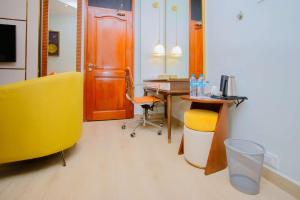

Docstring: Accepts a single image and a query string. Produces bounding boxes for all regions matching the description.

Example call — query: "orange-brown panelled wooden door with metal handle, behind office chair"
[85,6,133,121]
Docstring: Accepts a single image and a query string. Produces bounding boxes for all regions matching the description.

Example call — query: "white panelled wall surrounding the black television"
[0,0,39,84]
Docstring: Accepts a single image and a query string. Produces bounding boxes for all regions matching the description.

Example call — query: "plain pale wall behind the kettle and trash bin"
[206,0,300,182]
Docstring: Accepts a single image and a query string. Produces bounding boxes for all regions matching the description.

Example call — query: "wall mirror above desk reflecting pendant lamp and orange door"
[165,0,204,77]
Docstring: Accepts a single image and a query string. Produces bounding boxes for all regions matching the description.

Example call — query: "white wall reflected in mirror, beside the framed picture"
[48,14,77,73]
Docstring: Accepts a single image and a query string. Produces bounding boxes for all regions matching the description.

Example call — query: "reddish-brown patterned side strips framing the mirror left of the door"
[39,0,83,76]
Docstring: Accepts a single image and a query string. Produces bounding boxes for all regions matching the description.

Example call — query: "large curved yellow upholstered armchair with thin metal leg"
[0,72,83,165]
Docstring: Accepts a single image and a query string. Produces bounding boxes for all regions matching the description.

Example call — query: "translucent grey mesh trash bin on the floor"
[225,139,265,195]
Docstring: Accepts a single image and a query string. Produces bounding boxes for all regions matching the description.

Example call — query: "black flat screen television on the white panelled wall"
[0,24,16,62]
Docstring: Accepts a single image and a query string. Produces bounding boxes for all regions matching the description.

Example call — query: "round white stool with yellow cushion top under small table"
[184,109,218,168]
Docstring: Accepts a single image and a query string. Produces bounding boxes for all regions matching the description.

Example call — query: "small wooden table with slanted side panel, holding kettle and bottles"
[178,95,234,175]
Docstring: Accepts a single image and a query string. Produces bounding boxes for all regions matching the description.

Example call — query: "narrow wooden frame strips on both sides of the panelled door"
[84,0,135,122]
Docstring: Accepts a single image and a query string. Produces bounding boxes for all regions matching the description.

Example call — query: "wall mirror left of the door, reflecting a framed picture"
[40,0,82,76]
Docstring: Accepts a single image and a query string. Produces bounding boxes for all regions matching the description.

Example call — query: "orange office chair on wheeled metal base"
[122,67,163,137]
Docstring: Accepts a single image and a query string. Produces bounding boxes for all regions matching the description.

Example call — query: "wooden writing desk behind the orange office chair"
[144,79,190,143]
